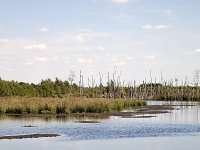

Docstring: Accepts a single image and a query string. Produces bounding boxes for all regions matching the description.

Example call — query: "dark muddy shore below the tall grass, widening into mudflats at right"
[0,104,188,118]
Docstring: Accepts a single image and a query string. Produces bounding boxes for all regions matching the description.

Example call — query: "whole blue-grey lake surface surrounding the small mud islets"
[0,101,200,150]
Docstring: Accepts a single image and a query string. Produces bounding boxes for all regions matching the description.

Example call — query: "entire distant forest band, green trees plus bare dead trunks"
[0,69,200,101]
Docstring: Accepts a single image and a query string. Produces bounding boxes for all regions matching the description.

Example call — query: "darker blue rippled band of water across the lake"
[0,122,200,140]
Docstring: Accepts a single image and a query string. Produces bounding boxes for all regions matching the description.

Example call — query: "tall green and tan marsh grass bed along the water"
[0,97,146,114]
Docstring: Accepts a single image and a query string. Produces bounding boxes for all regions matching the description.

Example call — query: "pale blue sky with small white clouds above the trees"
[0,0,200,83]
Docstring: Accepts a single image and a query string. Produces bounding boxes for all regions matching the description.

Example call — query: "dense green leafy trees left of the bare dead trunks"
[0,78,78,97]
